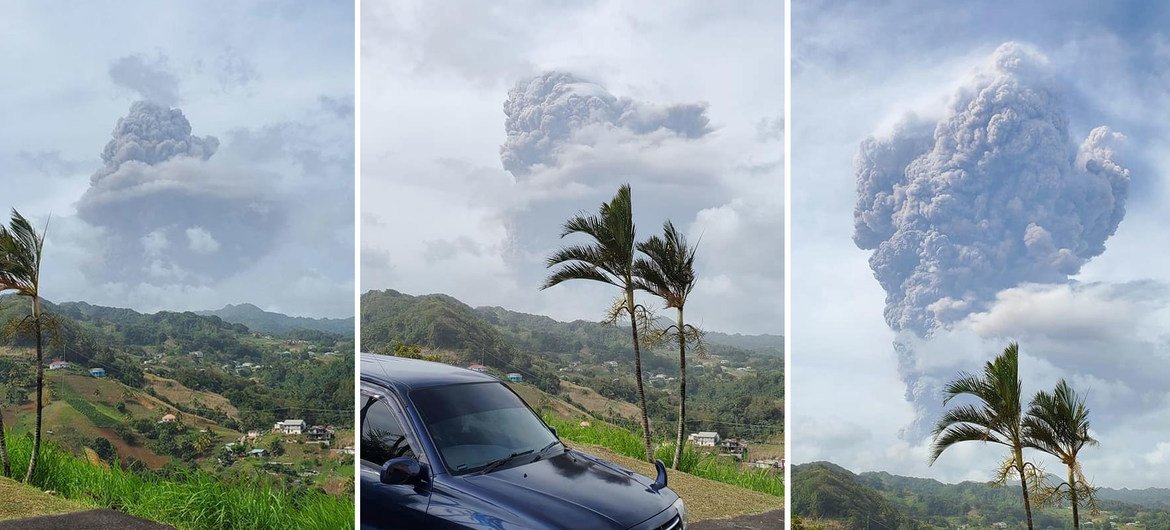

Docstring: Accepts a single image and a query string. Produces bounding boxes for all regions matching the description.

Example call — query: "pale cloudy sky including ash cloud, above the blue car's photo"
[360,1,784,333]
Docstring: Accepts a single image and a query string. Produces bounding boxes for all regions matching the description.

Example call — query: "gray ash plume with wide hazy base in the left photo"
[77,102,283,280]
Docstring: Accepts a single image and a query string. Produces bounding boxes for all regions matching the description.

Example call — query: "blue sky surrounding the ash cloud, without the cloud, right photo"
[790,1,1170,487]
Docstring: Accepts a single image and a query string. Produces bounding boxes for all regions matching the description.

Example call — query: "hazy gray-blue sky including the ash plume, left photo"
[0,1,355,317]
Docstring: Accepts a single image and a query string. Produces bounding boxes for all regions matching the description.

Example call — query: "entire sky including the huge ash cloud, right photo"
[789,1,1170,488]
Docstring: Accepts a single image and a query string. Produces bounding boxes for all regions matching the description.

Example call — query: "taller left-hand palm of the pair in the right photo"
[930,343,1032,530]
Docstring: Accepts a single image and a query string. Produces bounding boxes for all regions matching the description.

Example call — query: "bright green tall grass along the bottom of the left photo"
[8,436,353,530]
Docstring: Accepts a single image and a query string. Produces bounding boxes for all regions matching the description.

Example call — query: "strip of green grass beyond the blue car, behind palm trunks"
[544,414,784,497]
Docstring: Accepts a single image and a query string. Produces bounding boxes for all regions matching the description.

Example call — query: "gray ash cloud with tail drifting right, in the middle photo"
[500,71,711,178]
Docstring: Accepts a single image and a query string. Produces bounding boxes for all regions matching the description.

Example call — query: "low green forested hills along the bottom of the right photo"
[792,462,1170,529]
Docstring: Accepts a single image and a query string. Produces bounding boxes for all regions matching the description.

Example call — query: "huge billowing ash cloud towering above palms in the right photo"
[853,43,1130,336]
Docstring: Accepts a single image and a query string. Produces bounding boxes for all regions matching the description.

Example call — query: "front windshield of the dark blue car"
[411,383,557,475]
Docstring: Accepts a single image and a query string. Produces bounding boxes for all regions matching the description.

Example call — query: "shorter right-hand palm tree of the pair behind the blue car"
[634,221,701,469]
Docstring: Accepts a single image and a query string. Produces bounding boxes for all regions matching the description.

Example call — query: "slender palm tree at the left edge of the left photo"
[0,208,48,482]
